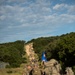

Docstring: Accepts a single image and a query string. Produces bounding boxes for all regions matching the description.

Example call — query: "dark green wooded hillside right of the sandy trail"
[28,32,75,70]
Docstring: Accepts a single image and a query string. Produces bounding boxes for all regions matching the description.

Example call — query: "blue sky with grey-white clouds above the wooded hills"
[0,0,75,43]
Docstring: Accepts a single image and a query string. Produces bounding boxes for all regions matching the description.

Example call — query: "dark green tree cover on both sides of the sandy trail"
[0,32,75,72]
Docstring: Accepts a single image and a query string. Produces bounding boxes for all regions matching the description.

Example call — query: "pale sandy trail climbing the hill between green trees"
[24,43,38,62]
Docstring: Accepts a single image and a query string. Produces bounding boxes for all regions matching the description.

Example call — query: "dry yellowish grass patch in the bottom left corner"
[0,64,24,75]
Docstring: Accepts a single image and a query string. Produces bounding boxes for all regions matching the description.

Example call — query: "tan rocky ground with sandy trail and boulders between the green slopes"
[24,43,74,75]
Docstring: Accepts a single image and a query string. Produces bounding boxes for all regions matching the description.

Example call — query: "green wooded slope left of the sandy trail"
[0,41,25,67]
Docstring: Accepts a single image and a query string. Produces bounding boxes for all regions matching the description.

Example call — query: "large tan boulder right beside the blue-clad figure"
[44,59,61,75]
